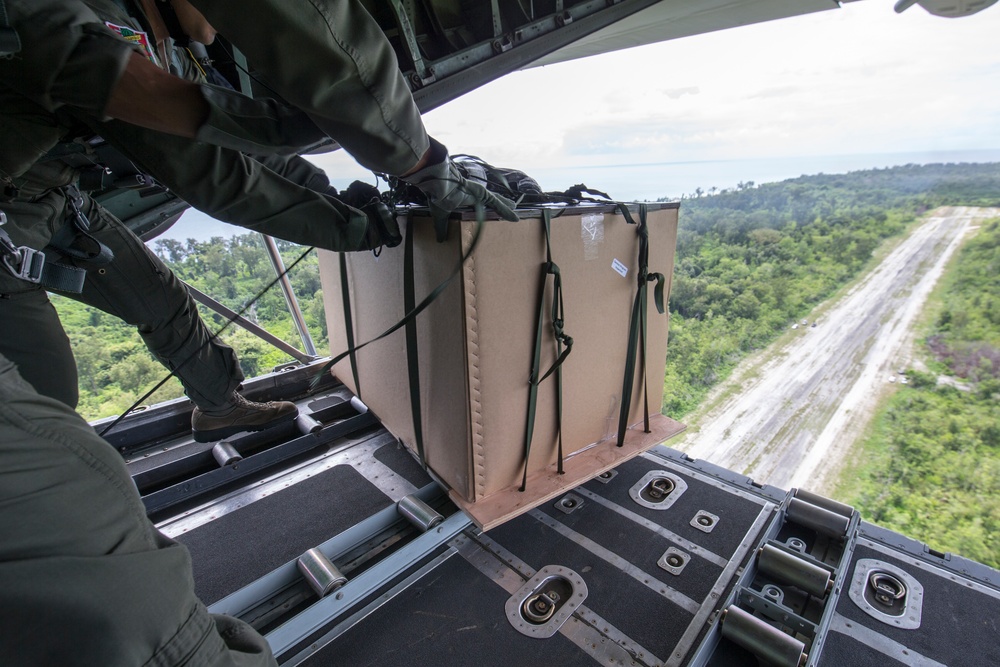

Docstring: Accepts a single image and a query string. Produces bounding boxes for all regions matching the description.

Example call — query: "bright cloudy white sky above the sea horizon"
[308,0,1000,175]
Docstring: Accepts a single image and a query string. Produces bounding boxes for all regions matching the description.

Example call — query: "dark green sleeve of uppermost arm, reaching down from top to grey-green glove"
[191,0,430,175]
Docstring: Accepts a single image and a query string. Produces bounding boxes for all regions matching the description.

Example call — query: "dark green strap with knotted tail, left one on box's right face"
[518,209,573,491]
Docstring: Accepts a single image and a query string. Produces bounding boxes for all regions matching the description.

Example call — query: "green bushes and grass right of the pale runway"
[836,220,1000,567]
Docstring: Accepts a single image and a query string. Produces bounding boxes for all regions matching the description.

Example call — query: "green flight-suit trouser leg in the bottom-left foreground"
[0,356,277,667]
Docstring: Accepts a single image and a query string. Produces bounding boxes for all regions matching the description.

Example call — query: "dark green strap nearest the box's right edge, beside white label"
[617,204,666,447]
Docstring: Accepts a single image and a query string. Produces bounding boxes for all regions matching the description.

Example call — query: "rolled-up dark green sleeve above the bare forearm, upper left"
[0,0,133,116]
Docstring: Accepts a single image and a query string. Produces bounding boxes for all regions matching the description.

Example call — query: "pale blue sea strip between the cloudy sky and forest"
[161,149,1000,241]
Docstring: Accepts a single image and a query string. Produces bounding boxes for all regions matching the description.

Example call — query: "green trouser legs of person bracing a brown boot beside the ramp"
[0,170,243,409]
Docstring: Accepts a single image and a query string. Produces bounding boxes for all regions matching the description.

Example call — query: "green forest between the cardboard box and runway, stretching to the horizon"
[663,164,1000,419]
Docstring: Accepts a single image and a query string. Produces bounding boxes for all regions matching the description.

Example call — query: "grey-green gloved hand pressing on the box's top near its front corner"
[401,137,518,222]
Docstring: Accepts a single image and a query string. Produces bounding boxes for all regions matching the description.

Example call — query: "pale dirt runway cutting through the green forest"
[667,207,1000,493]
